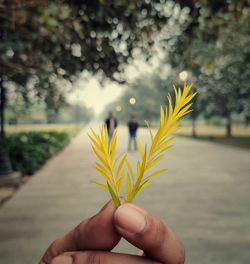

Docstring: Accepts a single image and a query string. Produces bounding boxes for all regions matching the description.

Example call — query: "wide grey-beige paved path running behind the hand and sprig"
[0,128,250,264]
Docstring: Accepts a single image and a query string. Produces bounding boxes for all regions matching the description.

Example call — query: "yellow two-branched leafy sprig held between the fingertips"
[89,84,195,207]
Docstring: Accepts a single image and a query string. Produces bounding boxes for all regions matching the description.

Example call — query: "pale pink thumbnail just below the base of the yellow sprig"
[115,204,146,234]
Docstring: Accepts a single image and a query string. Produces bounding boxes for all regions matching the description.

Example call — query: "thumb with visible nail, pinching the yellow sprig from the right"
[114,204,185,264]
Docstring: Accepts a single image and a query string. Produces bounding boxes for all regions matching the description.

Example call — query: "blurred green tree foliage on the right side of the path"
[161,1,250,137]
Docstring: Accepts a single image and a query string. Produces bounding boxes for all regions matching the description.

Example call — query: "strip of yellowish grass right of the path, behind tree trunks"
[176,123,250,149]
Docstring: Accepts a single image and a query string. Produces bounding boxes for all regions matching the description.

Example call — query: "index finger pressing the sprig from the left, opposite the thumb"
[40,202,121,264]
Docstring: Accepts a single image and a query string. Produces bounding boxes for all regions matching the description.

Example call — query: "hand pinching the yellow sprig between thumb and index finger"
[40,202,185,264]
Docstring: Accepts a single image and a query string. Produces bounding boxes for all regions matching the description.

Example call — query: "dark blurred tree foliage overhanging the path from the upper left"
[0,0,168,140]
